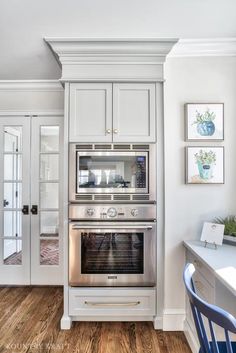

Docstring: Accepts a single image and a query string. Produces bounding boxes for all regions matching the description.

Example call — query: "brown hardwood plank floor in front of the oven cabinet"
[0,287,191,353]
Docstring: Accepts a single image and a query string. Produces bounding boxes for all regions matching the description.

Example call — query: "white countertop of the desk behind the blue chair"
[184,240,236,296]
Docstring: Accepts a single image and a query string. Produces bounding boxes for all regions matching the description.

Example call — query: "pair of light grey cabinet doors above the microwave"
[69,83,156,143]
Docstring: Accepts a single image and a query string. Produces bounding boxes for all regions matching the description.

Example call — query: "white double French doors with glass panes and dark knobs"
[0,116,63,285]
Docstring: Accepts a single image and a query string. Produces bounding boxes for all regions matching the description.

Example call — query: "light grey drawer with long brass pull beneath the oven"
[69,288,156,316]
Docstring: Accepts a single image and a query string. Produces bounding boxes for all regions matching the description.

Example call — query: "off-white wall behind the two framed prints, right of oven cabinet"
[164,57,236,328]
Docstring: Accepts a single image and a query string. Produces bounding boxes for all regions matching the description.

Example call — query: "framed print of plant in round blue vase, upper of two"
[185,103,224,141]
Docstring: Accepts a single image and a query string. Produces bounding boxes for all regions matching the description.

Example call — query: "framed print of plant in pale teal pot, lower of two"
[186,146,224,184]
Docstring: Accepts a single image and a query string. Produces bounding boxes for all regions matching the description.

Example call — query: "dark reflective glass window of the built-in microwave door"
[77,154,147,193]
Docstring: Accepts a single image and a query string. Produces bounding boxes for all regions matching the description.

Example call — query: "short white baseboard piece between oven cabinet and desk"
[163,309,185,331]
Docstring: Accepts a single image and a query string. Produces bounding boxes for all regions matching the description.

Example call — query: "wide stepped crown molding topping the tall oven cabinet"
[44,38,177,81]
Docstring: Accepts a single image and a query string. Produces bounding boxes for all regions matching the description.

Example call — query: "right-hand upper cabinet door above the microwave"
[113,83,156,142]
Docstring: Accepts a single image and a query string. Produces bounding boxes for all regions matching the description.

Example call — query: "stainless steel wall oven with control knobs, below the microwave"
[69,205,156,286]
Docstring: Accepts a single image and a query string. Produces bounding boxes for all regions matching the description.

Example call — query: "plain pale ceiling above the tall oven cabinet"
[0,0,236,80]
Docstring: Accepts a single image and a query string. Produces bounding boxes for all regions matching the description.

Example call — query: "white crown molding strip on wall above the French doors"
[0,80,63,92]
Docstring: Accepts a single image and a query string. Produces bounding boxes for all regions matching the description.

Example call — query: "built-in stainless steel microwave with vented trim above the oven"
[69,143,156,202]
